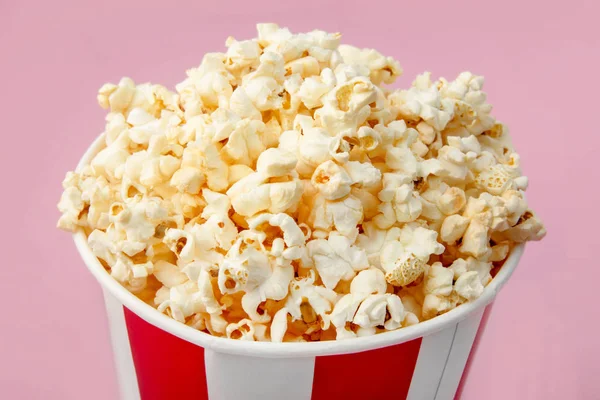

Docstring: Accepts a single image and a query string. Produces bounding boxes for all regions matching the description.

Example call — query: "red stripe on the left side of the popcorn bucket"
[123,307,208,400]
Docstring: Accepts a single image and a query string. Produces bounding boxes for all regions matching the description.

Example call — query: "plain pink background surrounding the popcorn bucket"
[0,0,600,400]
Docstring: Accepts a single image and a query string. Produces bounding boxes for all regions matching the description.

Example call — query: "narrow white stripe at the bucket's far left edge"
[104,290,140,400]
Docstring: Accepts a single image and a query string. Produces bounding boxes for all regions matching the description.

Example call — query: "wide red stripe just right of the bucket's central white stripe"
[312,338,421,400]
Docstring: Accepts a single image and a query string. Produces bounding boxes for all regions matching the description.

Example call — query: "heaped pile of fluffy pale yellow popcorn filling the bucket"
[58,24,545,342]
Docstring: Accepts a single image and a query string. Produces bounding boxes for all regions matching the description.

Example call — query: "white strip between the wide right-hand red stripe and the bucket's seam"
[406,325,456,400]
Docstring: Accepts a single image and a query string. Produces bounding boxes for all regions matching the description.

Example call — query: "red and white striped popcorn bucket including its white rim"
[74,136,524,400]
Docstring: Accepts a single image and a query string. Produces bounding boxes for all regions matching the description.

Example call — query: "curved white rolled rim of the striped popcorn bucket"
[73,134,525,358]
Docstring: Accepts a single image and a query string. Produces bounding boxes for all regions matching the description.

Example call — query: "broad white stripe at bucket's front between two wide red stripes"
[204,349,315,400]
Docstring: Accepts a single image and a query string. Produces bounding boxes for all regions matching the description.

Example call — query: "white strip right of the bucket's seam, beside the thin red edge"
[435,307,485,400]
